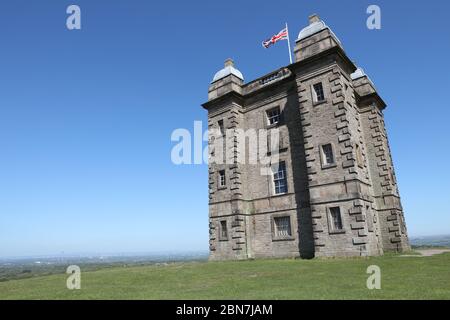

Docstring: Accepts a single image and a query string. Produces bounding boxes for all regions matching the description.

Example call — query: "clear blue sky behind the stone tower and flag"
[0,0,450,257]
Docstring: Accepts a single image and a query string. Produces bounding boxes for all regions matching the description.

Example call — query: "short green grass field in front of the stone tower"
[0,253,450,300]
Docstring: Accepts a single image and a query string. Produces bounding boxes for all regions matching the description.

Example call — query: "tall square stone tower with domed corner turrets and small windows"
[203,15,409,260]
